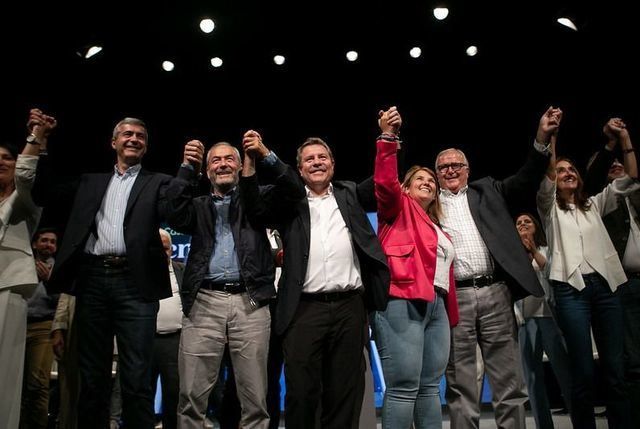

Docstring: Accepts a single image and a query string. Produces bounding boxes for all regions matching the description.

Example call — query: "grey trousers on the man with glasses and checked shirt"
[446,283,527,429]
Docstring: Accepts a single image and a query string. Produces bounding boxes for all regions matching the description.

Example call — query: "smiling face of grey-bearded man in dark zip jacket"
[207,143,242,195]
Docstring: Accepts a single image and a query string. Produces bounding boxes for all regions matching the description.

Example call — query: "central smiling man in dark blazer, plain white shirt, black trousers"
[240,138,389,429]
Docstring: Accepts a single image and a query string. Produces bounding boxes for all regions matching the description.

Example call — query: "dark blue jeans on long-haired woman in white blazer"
[553,273,631,429]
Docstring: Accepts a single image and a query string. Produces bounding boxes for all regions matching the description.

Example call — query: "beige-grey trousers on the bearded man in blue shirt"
[178,289,271,429]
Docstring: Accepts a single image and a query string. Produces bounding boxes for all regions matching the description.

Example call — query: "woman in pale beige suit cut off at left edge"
[0,109,56,429]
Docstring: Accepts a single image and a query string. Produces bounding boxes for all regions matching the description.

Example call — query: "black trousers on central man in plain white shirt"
[283,295,367,429]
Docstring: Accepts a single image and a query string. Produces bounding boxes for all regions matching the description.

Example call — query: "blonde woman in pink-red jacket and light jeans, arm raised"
[374,107,458,429]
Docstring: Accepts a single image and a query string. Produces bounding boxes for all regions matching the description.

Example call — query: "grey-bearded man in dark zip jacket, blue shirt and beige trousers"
[168,131,300,429]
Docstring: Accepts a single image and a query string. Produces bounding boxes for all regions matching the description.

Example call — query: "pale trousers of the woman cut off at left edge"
[0,289,27,429]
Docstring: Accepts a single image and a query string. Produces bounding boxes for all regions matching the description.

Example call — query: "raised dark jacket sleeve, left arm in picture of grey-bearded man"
[162,167,197,234]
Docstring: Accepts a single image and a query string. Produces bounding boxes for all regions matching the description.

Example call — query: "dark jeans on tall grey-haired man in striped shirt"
[73,263,158,429]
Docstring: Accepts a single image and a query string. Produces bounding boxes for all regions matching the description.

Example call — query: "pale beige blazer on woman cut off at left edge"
[0,155,42,298]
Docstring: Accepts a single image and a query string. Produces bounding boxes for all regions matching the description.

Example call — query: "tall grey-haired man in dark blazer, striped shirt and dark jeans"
[33,118,171,429]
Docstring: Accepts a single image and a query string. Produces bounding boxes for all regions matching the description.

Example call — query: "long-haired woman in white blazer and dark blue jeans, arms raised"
[537,134,640,429]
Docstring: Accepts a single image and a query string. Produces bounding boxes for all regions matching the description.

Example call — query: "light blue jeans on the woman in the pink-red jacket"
[375,295,451,429]
